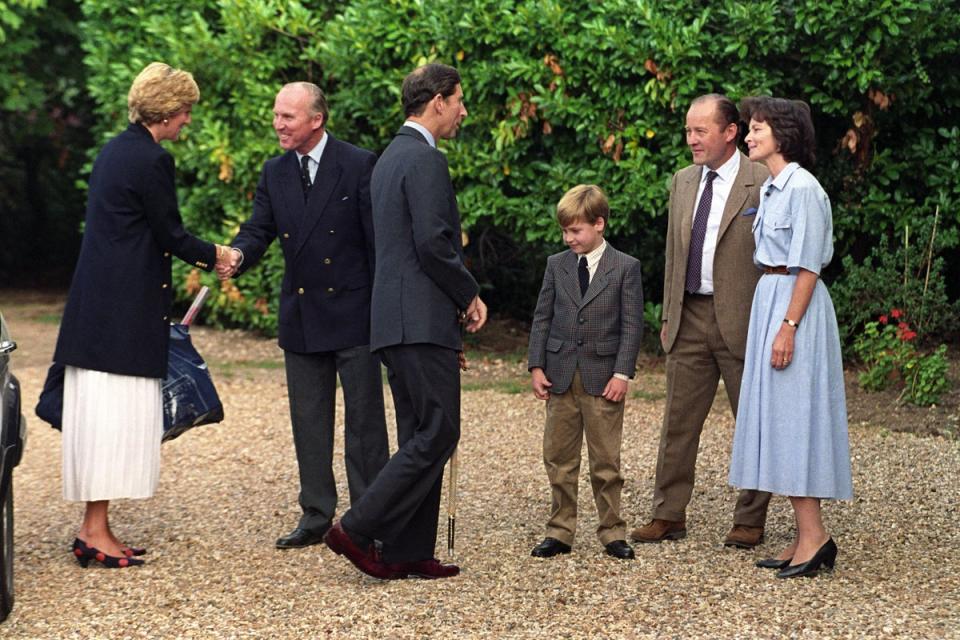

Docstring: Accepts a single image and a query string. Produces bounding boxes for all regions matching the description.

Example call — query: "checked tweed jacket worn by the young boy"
[527,243,643,396]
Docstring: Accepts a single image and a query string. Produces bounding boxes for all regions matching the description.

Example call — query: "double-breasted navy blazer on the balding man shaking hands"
[232,132,377,353]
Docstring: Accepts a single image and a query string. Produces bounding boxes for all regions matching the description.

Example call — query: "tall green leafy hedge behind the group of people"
[75,0,960,340]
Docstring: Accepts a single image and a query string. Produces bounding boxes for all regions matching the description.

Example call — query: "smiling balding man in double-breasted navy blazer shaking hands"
[218,82,388,549]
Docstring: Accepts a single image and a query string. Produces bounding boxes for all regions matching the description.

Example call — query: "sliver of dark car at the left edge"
[0,315,27,622]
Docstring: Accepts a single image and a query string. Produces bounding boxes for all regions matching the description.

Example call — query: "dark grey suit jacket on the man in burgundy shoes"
[370,127,479,350]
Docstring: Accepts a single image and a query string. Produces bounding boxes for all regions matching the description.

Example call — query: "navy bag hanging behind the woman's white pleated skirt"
[36,296,223,442]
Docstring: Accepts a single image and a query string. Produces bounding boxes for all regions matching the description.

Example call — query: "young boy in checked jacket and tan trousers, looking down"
[527,185,643,559]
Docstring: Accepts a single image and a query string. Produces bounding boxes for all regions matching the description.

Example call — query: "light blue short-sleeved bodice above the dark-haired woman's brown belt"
[753,162,833,274]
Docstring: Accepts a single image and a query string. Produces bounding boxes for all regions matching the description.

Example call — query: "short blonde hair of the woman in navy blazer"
[127,62,200,124]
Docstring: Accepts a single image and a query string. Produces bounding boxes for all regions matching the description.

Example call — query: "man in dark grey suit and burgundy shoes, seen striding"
[324,64,487,579]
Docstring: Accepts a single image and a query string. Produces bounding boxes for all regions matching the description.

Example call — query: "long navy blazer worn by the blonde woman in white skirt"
[53,124,216,378]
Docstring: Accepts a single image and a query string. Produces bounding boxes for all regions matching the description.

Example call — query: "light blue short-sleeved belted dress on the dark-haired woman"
[729,163,853,500]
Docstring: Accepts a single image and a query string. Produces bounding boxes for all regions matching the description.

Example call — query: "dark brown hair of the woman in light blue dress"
[740,96,816,170]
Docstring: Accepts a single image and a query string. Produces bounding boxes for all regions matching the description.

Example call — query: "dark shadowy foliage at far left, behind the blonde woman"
[0,0,91,287]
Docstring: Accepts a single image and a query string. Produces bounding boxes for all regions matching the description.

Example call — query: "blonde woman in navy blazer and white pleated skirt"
[53,62,227,567]
